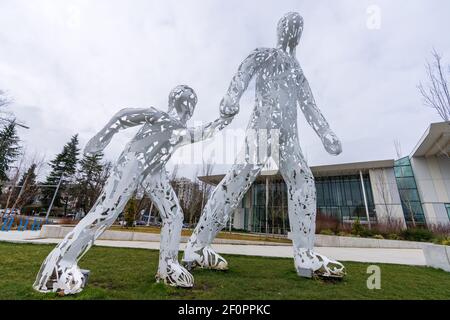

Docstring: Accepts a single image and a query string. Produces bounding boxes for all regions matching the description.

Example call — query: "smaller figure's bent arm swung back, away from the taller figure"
[84,108,158,154]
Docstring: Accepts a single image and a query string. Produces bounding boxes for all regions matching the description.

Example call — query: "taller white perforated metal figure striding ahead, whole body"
[183,12,345,277]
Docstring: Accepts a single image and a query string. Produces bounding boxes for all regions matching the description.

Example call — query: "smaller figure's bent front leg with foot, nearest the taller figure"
[143,171,194,288]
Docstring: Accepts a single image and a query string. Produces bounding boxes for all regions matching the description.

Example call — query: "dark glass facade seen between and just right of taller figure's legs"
[242,174,376,234]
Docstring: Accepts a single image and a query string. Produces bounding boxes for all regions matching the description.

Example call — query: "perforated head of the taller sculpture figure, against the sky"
[277,12,303,54]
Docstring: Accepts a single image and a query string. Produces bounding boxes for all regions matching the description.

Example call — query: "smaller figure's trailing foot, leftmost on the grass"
[33,248,88,295]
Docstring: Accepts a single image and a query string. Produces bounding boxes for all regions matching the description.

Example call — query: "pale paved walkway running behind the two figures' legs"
[0,231,426,266]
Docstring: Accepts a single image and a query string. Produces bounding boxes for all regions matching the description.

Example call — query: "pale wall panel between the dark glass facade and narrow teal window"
[369,168,406,228]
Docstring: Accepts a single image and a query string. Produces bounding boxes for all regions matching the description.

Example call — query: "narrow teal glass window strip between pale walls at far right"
[394,157,425,224]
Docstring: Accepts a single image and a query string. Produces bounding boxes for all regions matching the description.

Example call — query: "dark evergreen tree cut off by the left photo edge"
[0,121,20,183]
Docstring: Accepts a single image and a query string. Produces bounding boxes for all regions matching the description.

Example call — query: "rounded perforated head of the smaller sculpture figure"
[169,85,197,122]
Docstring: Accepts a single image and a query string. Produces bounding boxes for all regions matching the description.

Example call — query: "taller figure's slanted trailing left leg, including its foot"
[183,163,263,270]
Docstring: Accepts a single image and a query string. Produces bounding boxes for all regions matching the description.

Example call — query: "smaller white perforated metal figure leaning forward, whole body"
[33,86,232,294]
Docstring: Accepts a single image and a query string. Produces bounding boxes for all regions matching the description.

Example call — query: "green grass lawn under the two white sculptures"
[0,242,450,300]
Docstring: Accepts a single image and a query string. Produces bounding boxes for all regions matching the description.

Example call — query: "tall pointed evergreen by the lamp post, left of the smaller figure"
[43,135,80,207]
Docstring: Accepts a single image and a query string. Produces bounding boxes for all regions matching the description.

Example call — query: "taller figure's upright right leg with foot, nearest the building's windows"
[280,140,345,278]
